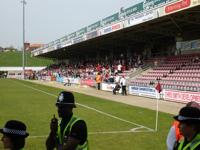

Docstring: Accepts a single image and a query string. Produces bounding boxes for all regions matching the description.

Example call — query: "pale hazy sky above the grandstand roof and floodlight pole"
[0,0,142,48]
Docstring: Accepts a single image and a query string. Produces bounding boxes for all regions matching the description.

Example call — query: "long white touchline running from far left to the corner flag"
[12,79,154,131]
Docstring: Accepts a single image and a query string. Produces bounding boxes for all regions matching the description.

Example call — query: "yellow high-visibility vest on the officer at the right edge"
[178,134,200,150]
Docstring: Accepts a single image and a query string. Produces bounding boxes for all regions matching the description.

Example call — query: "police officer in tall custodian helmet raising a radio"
[46,91,88,150]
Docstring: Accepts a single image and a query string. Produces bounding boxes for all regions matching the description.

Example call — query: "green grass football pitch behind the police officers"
[0,79,172,150]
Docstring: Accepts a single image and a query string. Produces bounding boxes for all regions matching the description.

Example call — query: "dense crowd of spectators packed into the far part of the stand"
[37,58,137,84]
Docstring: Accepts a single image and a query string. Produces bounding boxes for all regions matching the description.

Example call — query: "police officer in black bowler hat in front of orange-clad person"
[174,107,200,150]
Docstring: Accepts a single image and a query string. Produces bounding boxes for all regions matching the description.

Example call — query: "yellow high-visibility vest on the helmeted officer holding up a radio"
[57,116,89,150]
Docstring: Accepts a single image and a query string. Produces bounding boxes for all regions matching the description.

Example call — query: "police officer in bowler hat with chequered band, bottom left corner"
[0,120,29,150]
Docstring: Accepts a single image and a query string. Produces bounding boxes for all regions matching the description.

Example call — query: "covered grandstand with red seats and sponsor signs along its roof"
[31,0,200,103]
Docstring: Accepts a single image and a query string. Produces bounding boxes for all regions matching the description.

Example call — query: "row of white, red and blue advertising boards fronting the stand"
[36,76,200,103]
